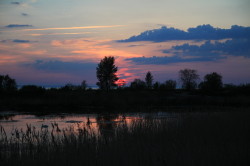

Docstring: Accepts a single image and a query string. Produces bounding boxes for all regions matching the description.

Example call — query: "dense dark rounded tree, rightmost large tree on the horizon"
[199,72,223,91]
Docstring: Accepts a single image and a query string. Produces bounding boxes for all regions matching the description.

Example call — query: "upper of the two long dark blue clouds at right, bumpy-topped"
[118,24,250,42]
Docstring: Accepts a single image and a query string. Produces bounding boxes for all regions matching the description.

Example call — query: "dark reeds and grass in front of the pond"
[0,111,250,166]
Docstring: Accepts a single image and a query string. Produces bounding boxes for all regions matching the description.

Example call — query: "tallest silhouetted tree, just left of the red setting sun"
[96,57,119,91]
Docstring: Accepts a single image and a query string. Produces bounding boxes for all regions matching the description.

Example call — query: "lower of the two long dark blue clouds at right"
[126,39,250,65]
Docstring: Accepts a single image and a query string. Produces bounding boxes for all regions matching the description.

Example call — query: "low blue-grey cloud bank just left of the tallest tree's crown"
[25,60,97,74]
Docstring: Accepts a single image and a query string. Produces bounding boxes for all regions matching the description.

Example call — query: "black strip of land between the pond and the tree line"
[0,85,250,113]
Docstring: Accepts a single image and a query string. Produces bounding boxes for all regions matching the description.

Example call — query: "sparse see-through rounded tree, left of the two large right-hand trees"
[179,69,199,90]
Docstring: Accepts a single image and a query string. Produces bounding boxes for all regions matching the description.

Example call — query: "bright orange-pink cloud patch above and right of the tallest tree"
[48,39,143,82]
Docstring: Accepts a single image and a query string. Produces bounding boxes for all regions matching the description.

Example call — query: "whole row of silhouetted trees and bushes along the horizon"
[0,56,249,92]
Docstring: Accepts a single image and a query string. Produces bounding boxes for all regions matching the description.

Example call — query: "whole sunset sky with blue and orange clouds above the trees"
[0,0,250,87]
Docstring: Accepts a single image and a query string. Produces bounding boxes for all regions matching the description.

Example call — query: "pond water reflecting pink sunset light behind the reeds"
[0,112,176,137]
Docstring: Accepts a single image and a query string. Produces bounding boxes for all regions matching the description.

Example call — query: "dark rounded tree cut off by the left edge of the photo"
[0,75,17,91]
